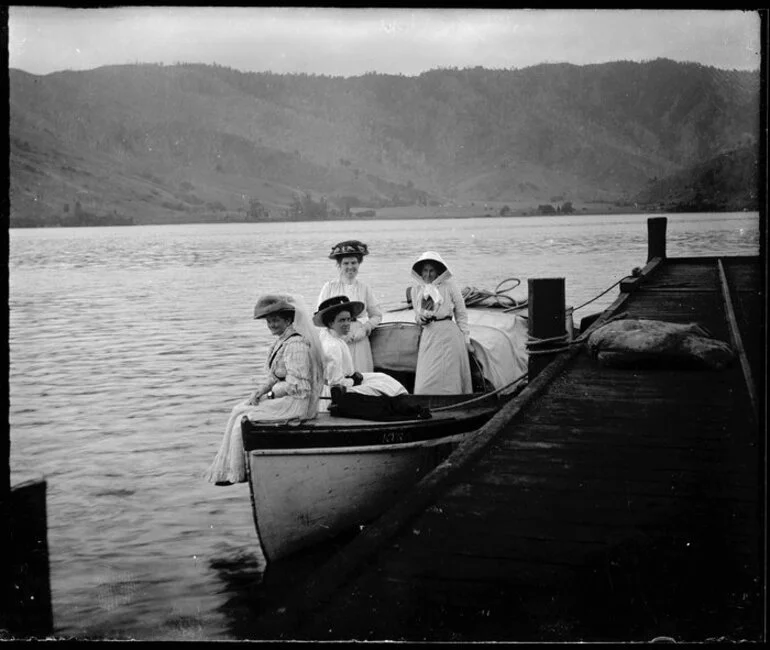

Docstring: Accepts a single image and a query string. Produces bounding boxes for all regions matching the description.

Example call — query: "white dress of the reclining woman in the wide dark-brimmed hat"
[319,328,408,410]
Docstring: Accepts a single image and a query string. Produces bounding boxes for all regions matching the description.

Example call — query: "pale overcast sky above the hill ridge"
[8,6,761,76]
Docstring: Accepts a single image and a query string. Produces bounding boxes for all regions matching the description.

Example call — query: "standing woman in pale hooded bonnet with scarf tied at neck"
[411,251,473,395]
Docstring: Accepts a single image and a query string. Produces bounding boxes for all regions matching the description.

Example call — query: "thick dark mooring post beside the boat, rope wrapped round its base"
[527,278,567,381]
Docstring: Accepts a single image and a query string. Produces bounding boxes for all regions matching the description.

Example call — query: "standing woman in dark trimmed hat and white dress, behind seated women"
[317,239,382,372]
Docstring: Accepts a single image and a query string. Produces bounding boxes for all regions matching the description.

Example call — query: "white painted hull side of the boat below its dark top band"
[248,436,452,561]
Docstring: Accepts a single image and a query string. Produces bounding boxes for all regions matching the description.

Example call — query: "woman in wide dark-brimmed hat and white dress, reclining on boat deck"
[313,296,407,409]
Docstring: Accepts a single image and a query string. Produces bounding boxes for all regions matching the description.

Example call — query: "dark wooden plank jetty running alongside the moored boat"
[252,220,765,642]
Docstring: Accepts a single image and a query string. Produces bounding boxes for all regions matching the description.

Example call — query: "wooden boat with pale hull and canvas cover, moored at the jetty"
[241,308,527,561]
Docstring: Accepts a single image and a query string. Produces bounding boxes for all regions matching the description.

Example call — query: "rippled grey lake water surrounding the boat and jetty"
[9,213,759,640]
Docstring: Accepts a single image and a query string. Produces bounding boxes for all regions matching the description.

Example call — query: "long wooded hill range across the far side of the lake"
[9,59,759,225]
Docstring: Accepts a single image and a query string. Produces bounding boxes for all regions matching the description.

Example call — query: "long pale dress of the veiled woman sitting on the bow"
[206,326,322,483]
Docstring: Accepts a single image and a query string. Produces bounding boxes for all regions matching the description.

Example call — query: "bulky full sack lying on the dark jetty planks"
[588,318,734,370]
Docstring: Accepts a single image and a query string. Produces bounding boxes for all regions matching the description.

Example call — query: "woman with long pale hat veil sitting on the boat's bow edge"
[207,294,325,485]
